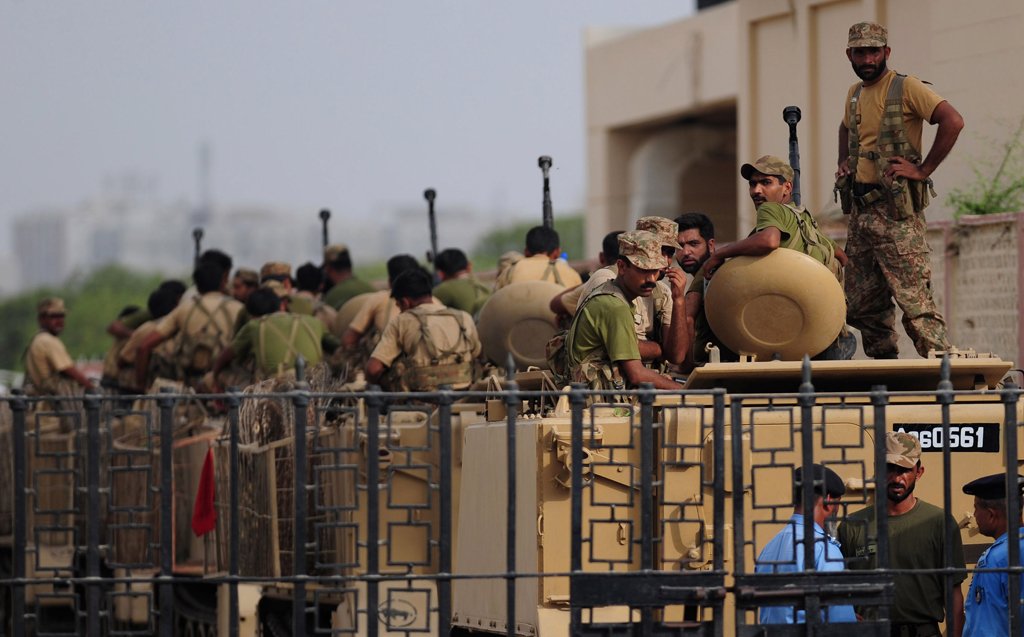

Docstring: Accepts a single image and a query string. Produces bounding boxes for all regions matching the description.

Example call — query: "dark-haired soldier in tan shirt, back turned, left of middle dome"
[367,268,480,391]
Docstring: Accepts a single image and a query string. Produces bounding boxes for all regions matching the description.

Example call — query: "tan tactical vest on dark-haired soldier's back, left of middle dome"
[388,307,474,391]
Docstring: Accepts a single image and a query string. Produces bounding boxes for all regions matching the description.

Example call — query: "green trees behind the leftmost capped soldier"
[0,265,161,370]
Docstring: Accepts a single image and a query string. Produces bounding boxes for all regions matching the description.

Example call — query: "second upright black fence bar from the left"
[83,390,102,635]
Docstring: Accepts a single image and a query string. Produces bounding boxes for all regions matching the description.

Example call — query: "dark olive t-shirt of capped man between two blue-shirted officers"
[839,500,966,624]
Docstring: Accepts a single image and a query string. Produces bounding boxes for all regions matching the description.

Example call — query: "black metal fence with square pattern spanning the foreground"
[0,369,1022,636]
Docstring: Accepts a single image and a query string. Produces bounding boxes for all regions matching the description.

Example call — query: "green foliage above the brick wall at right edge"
[949,119,1024,218]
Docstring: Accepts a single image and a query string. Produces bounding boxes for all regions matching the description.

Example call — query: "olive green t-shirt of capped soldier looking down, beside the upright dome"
[568,294,640,367]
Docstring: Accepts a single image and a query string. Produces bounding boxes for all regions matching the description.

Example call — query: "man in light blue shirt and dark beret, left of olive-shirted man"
[755,464,857,624]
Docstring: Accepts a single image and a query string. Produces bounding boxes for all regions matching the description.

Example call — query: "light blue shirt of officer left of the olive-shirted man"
[754,513,857,624]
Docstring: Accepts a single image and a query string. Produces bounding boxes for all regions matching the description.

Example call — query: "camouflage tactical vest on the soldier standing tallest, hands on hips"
[837,72,936,219]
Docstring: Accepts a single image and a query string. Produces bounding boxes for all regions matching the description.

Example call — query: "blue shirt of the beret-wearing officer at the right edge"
[964,530,1024,637]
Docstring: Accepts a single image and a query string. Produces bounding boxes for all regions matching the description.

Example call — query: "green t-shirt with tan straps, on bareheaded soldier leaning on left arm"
[231,312,324,376]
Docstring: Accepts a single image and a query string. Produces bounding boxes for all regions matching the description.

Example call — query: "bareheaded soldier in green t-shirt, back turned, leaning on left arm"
[207,288,337,390]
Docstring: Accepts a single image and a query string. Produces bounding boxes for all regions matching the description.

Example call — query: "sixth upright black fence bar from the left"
[367,385,382,637]
